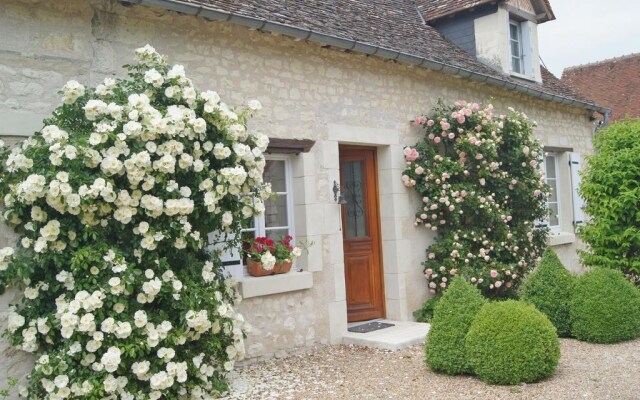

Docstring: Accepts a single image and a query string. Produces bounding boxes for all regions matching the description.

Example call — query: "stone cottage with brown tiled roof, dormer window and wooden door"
[0,0,608,381]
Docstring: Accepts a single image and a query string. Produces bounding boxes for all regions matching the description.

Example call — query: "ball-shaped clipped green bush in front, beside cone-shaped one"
[465,300,560,385]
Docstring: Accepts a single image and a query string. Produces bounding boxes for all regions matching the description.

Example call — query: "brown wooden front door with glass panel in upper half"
[340,146,385,322]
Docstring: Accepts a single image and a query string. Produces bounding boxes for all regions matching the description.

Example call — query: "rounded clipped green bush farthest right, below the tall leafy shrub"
[570,268,640,343]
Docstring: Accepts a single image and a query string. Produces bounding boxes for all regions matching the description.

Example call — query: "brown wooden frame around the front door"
[338,144,387,322]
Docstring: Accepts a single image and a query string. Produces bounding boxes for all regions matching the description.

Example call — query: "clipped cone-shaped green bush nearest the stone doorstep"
[425,277,486,375]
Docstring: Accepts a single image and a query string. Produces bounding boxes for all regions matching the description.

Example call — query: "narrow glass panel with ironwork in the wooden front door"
[342,160,369,239]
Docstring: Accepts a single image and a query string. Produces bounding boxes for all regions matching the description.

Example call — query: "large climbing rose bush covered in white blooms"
[0,45,270,399]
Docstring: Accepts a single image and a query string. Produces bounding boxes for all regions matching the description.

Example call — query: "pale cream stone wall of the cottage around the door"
[0,0,593,394]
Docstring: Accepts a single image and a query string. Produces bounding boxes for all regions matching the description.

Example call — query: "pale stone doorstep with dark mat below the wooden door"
[342,319,431,350]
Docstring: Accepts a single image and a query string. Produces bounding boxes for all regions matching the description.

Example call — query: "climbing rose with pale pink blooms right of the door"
[402,101,548,297]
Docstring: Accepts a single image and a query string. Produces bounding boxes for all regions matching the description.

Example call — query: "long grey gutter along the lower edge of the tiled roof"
[120,0,611,115]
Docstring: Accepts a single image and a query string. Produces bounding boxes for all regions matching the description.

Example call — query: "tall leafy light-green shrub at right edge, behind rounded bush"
[580,120,640,274]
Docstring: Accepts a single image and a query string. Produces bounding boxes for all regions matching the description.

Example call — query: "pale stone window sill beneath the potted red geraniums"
[239,271,313,299]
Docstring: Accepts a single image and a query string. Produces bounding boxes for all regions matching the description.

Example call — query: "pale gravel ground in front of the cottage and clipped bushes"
[220,339,640,400]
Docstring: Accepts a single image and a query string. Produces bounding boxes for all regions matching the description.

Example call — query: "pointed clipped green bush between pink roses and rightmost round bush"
[520,249,575,337]
